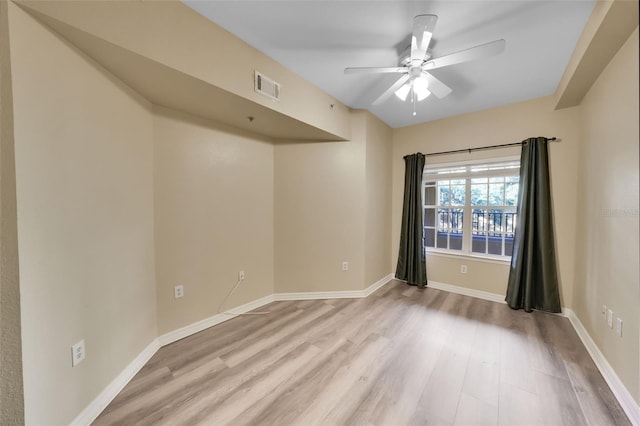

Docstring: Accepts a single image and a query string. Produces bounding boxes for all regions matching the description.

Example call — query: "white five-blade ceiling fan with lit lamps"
[344,15,506,115]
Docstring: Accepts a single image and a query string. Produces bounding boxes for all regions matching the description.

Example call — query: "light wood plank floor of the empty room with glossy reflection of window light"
[95,280,629,426]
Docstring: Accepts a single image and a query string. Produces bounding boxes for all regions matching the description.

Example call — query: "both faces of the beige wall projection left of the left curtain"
[275,111,392,293]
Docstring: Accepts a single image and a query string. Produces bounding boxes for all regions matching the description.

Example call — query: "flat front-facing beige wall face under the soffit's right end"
[274,112,367,293]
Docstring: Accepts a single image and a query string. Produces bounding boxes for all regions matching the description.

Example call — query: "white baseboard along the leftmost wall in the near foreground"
[71,339,160,426]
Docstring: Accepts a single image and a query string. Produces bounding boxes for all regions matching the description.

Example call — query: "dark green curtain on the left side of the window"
[396,152,427,287]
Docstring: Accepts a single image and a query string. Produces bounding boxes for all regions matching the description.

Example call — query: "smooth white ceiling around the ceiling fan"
[185,0,595,127]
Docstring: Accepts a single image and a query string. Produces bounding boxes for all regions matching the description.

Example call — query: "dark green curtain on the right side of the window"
[505,137,561,312]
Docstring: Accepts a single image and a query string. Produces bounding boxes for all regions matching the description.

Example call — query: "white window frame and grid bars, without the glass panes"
[421,156,520,262]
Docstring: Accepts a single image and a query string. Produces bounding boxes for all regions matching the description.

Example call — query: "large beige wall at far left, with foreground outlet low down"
[9,3,157,424]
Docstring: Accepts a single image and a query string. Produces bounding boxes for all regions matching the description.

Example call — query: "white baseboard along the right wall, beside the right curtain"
[564,309,640,425]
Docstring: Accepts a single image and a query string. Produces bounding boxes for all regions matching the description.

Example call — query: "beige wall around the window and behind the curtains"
[392,97,580,307]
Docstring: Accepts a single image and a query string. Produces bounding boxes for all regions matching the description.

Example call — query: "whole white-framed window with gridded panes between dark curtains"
[422,159,520,258]
